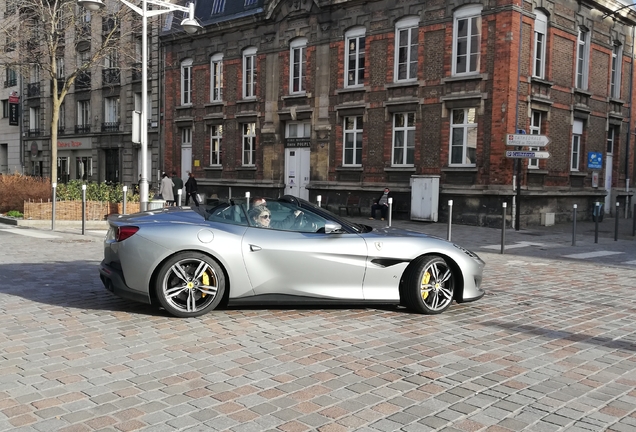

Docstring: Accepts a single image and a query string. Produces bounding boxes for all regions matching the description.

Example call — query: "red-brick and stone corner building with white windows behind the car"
[162,0,636,226]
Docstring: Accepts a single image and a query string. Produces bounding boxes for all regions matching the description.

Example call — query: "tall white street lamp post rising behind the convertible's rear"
[77,0,201,211]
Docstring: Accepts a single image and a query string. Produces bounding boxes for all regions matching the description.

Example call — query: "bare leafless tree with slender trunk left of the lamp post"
[0,0,135,182]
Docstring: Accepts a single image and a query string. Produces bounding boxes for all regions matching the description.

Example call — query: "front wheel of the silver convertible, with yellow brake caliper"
[400,255,455,315]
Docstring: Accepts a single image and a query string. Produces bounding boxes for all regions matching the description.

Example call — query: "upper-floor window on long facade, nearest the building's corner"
[453,6,481,75]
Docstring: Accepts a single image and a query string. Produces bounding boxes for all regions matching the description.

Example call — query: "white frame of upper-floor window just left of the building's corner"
[452,5,482,76]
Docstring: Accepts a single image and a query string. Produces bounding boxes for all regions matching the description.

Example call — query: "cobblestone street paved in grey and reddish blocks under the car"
[0,228,636,432]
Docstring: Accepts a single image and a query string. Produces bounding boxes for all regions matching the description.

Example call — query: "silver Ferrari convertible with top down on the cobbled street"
[99,196,484,317]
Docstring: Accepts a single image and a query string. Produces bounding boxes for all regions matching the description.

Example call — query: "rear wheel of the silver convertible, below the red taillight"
[156,252,225,318]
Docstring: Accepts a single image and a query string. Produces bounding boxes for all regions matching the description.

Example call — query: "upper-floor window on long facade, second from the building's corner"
[393,17,419,82]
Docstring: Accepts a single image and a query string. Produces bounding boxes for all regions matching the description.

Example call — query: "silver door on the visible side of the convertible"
[242,227,367,300]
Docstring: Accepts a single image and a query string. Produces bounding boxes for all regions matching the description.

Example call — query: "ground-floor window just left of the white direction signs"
[450,108,477,166]
